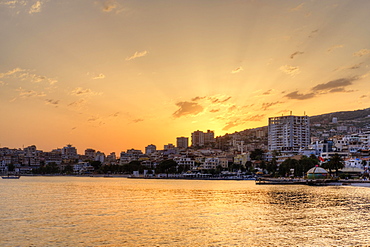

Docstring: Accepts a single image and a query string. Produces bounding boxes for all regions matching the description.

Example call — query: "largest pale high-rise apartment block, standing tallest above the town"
[268,115,310,152]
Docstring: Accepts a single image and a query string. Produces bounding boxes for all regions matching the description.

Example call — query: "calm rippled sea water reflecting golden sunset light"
[0,177,370,246]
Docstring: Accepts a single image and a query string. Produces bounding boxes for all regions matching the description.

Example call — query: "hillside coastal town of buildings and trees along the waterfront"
[0,112,370,178]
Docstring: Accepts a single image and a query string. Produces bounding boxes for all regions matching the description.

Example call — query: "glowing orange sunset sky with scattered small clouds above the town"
[0,0,370,154]
